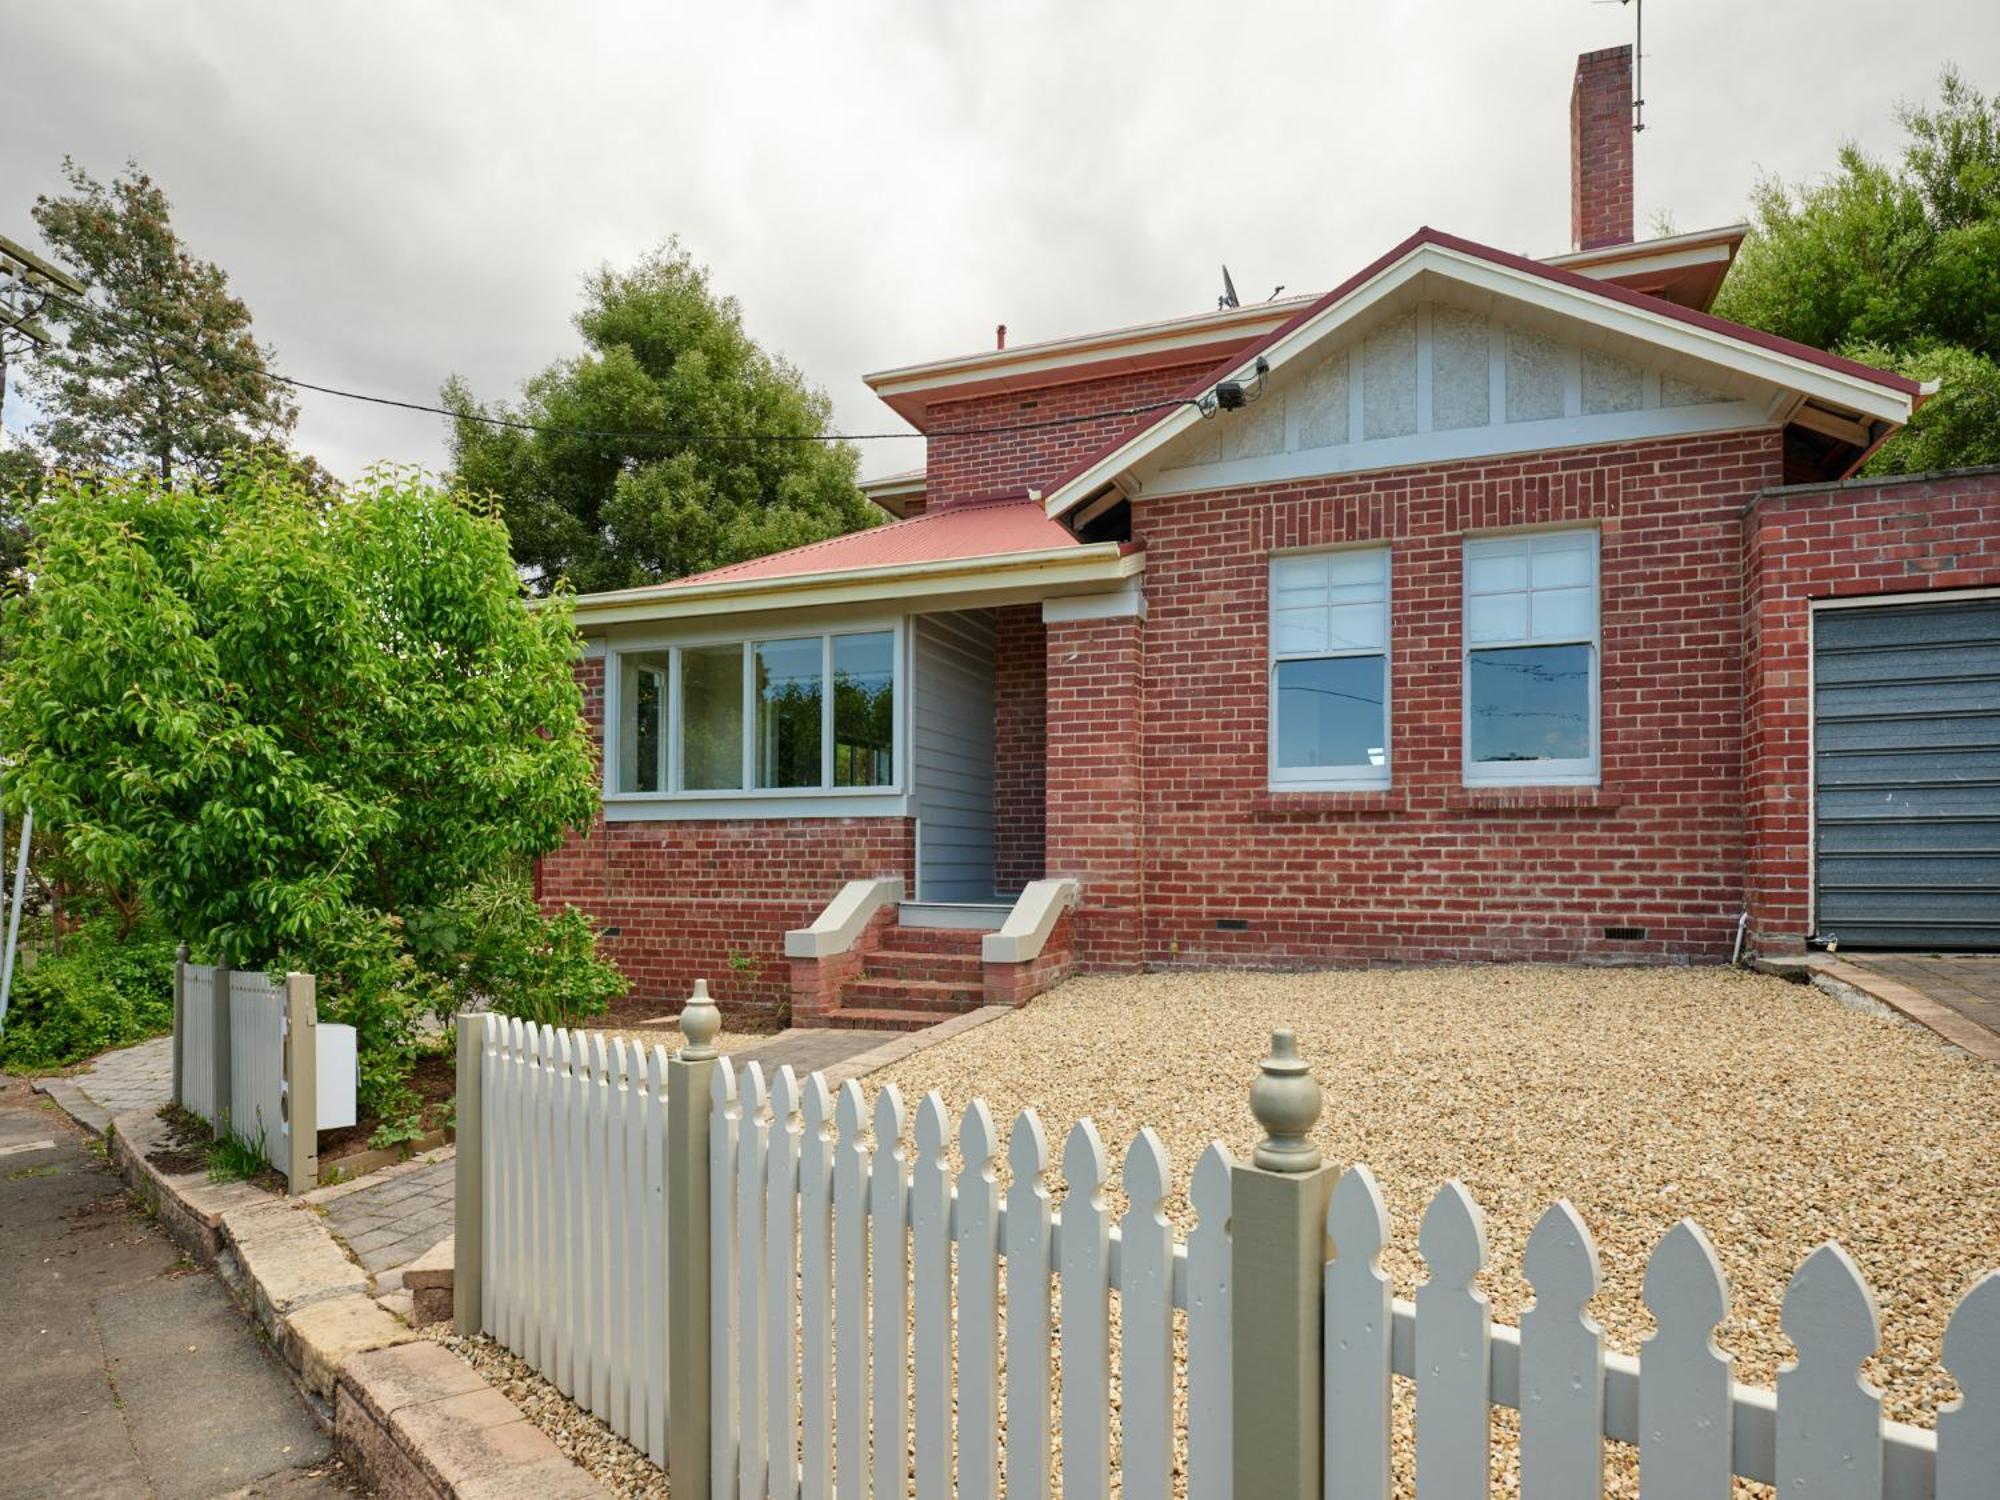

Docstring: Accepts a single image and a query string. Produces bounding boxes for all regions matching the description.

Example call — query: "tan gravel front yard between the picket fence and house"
[864,966,2000,1448]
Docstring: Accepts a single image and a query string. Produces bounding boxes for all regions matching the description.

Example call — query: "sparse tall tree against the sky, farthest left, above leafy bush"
[30,158,298,480]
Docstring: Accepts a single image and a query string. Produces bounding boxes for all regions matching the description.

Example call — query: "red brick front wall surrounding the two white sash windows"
[1048,434,1780,966]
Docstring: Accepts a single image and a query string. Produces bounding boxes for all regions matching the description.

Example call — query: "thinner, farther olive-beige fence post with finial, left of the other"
[666,980,724,1496]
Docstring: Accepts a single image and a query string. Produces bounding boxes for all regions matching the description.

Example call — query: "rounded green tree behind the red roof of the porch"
[444,240,882,592]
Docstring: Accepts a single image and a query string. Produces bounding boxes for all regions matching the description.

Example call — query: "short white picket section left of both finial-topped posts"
[466,1016,668,1464]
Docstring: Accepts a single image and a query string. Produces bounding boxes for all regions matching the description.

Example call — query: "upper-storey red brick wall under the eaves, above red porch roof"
[924,356,1216,510]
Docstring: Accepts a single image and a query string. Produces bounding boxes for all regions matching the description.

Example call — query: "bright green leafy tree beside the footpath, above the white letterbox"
[0,456,616,1116]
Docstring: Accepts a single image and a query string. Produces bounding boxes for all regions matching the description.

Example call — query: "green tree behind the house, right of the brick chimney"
[1716,68,2000,474]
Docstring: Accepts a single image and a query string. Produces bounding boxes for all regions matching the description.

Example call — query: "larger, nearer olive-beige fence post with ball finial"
[1230,1030,1336,1500]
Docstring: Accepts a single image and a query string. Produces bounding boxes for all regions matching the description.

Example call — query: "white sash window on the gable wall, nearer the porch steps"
[1270,548,1390,790]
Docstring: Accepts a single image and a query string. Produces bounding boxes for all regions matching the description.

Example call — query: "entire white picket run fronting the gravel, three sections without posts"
[460,1018,2000,1500]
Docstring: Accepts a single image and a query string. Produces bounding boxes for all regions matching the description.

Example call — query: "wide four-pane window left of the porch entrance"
[614,630,896,796]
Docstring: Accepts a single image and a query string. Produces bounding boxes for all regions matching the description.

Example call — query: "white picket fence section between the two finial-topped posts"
[708,1062,1230,1500]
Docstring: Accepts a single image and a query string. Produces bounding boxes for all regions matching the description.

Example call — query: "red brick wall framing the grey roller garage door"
[1744,470,2000,952]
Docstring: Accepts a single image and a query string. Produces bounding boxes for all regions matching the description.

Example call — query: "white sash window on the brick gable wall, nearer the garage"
[1464,528,1600,786]
